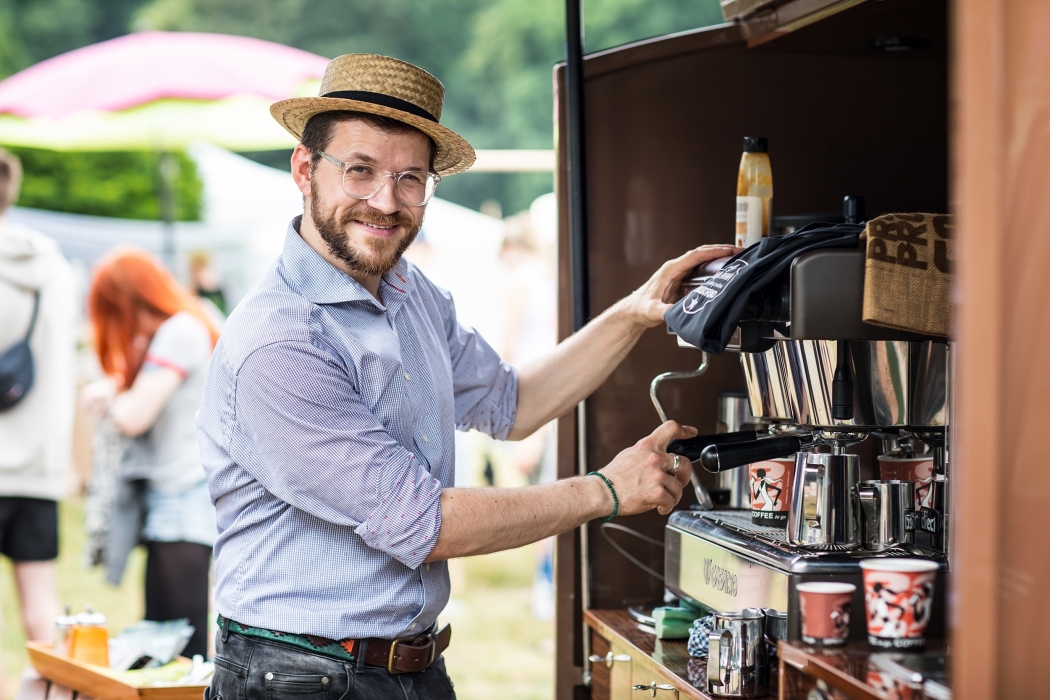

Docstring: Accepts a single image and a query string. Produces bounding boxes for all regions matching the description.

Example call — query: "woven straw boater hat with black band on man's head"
[270,54,475,175]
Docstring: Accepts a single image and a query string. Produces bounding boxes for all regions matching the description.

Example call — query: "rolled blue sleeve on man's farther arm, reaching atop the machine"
[443,289,518,440]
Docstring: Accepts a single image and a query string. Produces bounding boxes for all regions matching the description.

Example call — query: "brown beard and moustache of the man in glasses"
[310,189,423,277]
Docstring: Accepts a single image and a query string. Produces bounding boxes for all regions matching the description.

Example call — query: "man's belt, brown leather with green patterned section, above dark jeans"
[219,616,453,674]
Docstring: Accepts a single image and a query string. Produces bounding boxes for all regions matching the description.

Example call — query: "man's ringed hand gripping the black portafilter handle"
[600,421,697,515]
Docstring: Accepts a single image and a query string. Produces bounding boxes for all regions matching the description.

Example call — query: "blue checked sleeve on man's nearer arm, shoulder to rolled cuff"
[234,341,441,568]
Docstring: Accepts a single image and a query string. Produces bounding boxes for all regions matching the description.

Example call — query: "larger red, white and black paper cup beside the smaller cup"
[860,557,938,649]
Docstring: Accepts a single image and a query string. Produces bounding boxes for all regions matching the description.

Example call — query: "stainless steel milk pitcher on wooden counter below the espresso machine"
[708,608,770,698]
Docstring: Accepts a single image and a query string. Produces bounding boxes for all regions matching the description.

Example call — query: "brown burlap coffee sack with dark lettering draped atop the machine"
[861,214,953,336]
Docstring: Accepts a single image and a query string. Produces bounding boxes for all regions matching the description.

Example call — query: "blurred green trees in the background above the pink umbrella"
[0,0,721,219]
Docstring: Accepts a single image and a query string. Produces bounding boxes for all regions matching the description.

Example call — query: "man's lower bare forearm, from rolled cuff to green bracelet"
[426,476,612,561]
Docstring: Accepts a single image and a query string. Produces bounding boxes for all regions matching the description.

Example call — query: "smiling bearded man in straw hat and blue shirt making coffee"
[197,55,733,698]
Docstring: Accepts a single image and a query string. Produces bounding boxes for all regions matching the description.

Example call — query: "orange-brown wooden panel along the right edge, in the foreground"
[952,0,1050,700]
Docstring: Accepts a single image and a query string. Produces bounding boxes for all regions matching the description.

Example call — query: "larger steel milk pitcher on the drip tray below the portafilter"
[788,452,860,549]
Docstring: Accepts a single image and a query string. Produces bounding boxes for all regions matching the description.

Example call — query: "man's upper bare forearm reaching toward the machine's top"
[508,299,645,440]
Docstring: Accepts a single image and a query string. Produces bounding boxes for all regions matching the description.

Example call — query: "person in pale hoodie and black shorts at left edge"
[0,149,77,650]
